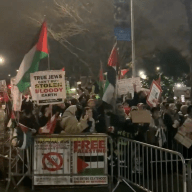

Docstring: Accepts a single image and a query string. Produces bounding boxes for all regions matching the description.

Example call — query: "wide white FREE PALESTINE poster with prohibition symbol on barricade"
[33,135,108,185]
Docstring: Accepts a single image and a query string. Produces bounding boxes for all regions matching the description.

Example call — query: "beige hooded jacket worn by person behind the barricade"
[60,105,88,134]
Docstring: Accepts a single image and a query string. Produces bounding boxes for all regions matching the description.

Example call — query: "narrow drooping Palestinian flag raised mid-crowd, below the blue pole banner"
[102,44,118,104]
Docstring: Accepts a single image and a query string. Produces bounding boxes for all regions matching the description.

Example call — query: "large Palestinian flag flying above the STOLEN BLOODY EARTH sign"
[15,22,49,93]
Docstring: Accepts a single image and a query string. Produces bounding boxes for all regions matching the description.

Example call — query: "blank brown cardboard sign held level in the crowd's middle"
[131,110,151,123]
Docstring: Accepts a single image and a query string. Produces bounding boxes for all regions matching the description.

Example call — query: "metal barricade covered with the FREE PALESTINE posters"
[6,134,113,192]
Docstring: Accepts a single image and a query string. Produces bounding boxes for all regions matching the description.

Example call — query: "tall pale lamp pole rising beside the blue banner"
[131,0,136,77]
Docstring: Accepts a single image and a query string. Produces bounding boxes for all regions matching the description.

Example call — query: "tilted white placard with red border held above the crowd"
[147,81,162,107]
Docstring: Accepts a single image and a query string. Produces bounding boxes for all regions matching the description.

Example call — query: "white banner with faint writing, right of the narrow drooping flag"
[117,77,141,97]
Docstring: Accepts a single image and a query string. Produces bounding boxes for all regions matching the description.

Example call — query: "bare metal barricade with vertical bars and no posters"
[113,137,187,192]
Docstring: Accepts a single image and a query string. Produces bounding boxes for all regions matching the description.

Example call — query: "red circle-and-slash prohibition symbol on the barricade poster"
[42,152,63,171]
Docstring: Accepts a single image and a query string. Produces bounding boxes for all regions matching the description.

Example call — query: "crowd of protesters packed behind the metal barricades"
[6,83,192,157]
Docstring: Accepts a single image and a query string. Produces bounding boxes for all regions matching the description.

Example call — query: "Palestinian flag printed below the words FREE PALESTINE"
[77,154,106,175]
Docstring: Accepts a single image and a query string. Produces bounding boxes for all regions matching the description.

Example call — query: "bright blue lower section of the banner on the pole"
[114,27,131,41]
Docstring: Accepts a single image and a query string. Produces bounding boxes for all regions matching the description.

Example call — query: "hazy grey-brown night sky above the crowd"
[0,0,189,79]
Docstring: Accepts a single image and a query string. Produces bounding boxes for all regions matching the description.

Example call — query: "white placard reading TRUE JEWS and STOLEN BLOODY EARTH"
[30,70,66,105]
